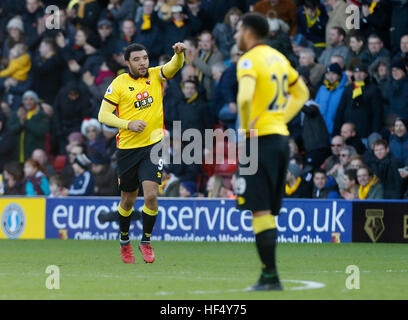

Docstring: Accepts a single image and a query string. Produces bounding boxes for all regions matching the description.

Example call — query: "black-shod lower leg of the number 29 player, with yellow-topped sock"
[247,210,283,291]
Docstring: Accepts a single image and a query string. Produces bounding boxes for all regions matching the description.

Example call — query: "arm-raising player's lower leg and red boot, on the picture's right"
[139,180,159,263]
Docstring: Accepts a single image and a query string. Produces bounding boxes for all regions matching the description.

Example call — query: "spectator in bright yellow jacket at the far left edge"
[0,43,31,93]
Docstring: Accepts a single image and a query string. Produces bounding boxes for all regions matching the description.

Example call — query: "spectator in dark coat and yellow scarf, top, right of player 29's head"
[297,0,329,55]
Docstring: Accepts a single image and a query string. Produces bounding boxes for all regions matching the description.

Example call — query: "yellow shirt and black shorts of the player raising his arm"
[98,53,184,192]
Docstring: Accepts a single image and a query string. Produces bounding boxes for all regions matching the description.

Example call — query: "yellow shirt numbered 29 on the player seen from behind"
[237,44,299,136]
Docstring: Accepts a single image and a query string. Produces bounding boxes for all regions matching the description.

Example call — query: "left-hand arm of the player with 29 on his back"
[237,76,256,130]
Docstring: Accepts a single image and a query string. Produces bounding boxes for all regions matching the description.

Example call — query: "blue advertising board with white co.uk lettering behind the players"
[46,198,352,243]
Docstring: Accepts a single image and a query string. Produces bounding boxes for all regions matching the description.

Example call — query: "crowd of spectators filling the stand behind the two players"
[0,0,408,200]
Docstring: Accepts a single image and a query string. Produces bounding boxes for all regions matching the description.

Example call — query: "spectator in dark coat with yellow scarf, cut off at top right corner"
[360,0,392,48]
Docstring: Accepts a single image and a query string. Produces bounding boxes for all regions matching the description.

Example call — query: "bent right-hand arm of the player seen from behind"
[284,76,309,123]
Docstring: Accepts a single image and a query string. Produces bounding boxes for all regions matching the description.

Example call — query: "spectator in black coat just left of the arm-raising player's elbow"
[53,81,94,154]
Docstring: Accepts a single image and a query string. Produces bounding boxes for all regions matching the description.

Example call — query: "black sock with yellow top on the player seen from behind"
[252,215,279,283]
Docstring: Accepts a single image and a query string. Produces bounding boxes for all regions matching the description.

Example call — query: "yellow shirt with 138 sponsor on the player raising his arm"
[104,66,166,149]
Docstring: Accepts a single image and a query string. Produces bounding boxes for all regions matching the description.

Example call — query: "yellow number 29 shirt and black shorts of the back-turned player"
[237,44,308,215]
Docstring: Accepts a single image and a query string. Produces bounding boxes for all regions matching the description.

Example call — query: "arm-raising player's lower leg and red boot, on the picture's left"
[118,190,138,263]
